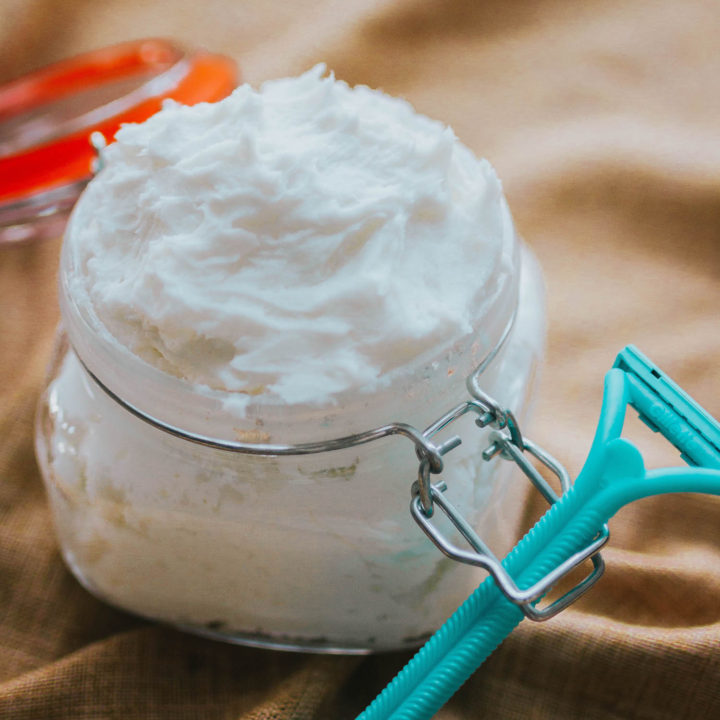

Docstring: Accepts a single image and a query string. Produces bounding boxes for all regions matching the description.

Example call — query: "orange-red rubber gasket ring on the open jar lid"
[0,39,238,202]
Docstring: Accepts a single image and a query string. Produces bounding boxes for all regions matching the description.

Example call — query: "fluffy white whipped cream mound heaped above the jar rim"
[66,66,510,403]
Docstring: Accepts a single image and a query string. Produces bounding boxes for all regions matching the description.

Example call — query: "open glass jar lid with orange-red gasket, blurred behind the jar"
[0,39,238,244]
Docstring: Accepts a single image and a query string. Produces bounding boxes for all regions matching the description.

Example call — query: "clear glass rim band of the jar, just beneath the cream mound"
[60,205,522,446]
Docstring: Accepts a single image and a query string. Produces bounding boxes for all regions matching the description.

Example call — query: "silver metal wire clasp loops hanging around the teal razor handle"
[410,376,609,621]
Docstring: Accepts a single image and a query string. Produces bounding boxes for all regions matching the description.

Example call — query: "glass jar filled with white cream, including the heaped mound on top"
[38,67,543,651]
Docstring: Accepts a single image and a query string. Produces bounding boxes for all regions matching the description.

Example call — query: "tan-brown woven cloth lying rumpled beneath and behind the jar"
[0,0,720,720]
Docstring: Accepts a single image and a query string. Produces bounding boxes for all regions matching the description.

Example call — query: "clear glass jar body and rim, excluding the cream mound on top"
[37,212,545,652]
